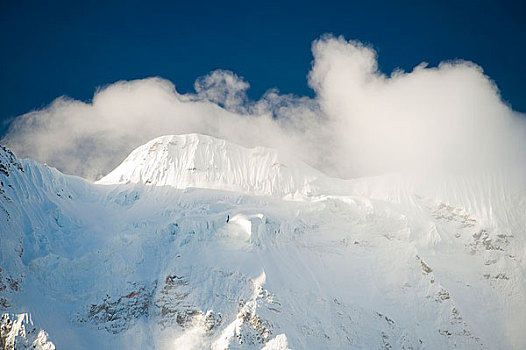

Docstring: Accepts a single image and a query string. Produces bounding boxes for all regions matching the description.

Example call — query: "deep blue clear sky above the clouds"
[0,0,526,134]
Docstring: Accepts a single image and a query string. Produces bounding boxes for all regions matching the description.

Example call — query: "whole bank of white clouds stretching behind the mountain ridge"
[2,36,526,180]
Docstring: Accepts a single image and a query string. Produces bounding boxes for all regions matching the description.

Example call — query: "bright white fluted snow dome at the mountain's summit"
[98,134,325,196]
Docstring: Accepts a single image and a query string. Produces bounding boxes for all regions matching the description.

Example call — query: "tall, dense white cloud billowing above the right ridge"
[309,38,525,175]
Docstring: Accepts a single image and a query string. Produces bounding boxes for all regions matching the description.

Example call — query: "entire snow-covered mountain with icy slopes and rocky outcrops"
[0,135,526,349]
